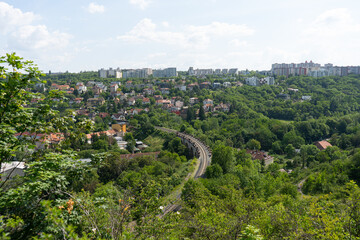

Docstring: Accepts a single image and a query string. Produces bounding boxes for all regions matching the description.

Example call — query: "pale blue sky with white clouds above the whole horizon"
[0,0,360,72]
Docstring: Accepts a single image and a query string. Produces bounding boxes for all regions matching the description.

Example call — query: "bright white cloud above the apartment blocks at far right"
[298,8,360,65]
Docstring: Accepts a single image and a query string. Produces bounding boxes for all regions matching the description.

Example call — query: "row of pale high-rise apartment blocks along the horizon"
[99,61,360,79]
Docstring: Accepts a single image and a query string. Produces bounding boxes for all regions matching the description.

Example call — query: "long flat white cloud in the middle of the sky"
[117,18,255,49]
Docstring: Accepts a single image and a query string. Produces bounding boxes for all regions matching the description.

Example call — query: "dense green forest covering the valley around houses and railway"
[0,54,360,239]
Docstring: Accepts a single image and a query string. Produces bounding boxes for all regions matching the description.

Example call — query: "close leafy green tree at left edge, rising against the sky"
[0,53,44,164]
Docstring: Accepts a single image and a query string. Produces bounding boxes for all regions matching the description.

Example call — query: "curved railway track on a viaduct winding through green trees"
[155,127,211,216]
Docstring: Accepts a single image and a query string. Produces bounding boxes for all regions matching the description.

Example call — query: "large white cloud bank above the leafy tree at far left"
[0,2,72,70]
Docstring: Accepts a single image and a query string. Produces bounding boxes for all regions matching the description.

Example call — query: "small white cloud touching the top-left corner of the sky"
[0,2,40,34]
